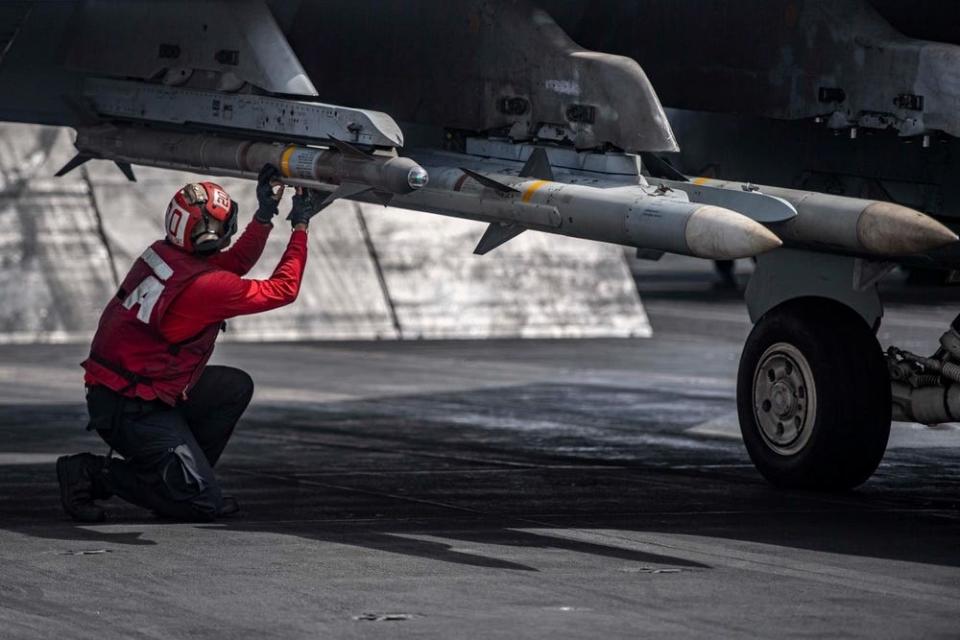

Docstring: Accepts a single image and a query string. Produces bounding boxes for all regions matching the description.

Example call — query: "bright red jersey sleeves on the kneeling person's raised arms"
[160,220,307,342]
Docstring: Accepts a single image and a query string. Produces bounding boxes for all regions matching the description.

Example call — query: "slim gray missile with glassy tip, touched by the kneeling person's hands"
[57,125,427,203]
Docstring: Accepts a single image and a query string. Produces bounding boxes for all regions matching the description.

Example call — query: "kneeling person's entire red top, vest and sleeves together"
[83,221,307,392]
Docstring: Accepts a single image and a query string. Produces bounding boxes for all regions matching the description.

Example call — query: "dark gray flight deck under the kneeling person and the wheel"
[0,262,960,639]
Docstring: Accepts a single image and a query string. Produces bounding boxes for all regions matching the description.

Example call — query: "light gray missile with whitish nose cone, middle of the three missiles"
[378,153,781,260]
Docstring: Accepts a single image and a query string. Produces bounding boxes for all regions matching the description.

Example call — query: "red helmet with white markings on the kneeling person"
[164,182,237,254]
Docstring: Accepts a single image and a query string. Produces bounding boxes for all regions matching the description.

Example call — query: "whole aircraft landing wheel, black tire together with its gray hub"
[737,298,891,491]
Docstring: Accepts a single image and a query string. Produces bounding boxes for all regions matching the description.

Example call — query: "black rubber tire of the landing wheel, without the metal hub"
[737,298,891,491]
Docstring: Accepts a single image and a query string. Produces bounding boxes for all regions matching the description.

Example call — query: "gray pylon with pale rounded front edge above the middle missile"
[287,0,677,151]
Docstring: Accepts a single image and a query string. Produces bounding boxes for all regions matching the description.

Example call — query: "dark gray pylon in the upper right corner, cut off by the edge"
[543,0,960,136]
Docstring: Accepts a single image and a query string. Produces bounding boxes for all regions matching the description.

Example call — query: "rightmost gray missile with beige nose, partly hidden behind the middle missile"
[650,178,958,257]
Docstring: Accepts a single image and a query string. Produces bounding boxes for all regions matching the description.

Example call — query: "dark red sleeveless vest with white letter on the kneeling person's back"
[82,240,221,405]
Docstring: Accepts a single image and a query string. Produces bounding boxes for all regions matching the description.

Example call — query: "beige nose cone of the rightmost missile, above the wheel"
[857,202,958,256]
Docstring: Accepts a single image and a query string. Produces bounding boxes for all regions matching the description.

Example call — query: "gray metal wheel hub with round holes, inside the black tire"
[753,342,816,455]
